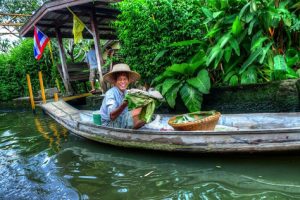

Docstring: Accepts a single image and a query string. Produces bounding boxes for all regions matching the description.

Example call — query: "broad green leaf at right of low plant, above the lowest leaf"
[187,69,210,94]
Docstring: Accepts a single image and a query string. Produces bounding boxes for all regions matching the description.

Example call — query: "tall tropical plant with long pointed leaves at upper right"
[202,0,300,85]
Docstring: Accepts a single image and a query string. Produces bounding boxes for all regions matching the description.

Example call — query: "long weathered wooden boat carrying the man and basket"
[42,101,300,153]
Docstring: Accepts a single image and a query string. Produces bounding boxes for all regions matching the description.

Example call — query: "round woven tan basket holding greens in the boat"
[168,112,221,131]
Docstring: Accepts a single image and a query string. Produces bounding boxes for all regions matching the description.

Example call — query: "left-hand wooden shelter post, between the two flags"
[55,28,74,94]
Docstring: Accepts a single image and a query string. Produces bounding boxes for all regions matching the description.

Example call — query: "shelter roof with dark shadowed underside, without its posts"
[20,0,120,40]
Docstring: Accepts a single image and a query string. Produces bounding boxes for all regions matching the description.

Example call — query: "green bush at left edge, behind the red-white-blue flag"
[0,39,58,101]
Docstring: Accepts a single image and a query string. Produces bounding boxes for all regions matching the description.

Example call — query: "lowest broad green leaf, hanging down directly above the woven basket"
[179,83,203,112]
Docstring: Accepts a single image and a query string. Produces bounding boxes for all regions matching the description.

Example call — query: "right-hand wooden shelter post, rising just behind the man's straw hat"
[91,10,106,92]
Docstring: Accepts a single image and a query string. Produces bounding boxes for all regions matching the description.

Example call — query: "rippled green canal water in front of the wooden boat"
[0,110,300,200]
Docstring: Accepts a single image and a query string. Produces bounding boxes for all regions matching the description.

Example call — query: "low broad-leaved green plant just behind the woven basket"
[153,51,210,112]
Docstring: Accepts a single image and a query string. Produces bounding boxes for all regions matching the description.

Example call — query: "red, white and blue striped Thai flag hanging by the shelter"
[33,26,49,60]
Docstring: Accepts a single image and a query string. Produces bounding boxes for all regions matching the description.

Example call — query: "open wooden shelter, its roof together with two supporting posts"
[20,0,120,93]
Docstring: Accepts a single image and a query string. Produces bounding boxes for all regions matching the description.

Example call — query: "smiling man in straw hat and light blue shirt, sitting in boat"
[100,64,145,129]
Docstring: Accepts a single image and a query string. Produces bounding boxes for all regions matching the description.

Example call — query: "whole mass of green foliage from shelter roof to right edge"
[115,0,300,111]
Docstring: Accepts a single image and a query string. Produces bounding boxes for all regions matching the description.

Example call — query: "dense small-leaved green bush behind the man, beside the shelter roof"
[115,0,204,82]
